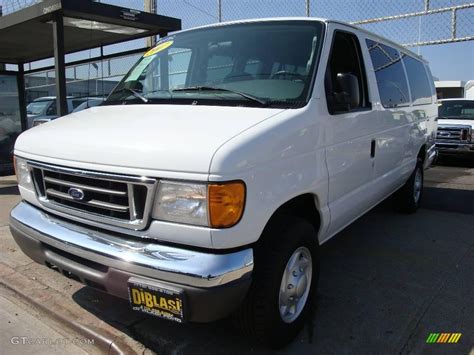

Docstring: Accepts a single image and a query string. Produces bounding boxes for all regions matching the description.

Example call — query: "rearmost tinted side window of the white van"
[403,54,431,105]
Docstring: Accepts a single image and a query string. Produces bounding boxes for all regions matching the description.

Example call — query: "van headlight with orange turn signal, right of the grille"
[153,181,245,228]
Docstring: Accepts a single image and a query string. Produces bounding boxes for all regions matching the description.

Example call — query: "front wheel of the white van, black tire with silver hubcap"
[234,216,319,348]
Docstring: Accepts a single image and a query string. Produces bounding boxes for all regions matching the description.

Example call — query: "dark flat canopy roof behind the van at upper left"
[0,0,181,64]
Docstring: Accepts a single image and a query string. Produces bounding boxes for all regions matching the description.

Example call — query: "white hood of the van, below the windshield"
[15,105,284,173]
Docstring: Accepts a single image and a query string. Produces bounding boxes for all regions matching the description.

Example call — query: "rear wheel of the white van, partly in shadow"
[395,159,424,214]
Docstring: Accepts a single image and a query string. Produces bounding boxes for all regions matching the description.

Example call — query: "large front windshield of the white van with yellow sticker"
[105,21,323,108]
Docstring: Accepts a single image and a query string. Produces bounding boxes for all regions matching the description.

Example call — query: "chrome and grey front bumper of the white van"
[10,202,253,321]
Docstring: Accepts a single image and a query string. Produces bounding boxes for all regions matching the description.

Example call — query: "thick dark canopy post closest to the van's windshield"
[53,14,68,116]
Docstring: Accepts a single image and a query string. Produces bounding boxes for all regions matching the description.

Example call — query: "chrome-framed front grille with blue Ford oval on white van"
[29,162,156,230]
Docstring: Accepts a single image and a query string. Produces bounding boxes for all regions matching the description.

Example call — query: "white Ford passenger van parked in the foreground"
[11,18,437,347]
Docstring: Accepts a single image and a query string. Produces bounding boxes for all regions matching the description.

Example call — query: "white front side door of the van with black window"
[322,25,377,236]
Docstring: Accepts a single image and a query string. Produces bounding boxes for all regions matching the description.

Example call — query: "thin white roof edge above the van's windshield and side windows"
[171,17,428,63]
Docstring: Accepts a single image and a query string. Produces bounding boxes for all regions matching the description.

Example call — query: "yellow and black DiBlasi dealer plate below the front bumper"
[128,279,184,323]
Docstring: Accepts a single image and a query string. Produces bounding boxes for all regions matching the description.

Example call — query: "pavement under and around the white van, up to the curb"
[0,164,474,354]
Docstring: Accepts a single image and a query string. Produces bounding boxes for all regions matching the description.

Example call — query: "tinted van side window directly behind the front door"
[366,39,410,108]
